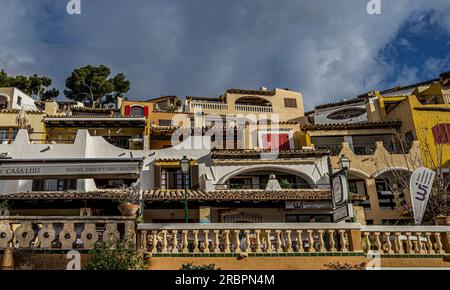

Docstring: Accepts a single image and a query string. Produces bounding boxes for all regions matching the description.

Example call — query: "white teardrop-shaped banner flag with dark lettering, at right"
[409,167,436,224]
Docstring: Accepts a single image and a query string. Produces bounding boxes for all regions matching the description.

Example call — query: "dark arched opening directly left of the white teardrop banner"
[375,169,411,210]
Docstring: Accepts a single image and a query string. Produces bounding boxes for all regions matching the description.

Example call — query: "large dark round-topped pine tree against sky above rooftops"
[64,65,130,108]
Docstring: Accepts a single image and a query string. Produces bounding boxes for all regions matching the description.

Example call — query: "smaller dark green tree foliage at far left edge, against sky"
[0,70,59,101]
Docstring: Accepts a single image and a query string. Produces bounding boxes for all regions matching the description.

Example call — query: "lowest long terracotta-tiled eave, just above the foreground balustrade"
[0,189,365,201]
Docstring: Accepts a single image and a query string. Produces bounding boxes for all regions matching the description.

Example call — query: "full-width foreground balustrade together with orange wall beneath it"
[0,217,450,269]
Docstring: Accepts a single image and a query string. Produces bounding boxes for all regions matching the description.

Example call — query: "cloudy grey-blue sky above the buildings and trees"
[0,0,450,109]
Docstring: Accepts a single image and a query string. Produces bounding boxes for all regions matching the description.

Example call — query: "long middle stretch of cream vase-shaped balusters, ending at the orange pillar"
[138,224,358,253]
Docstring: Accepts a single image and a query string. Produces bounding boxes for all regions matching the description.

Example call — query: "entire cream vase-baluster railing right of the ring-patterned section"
[138,223,450,255]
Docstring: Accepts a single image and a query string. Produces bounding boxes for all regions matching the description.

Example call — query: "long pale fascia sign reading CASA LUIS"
[0,162,140,178]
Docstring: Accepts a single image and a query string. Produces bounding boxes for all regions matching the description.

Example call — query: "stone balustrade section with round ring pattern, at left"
[0,216,136,250]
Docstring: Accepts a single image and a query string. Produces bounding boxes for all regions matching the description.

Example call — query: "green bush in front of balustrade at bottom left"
[85,240,146,271]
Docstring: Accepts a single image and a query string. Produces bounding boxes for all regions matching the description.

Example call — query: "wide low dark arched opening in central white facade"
[225,168,312,190]
